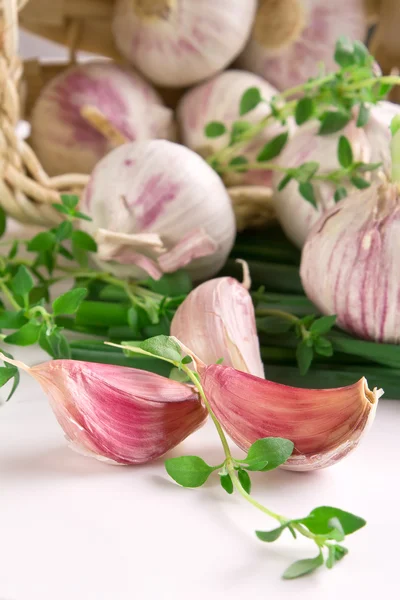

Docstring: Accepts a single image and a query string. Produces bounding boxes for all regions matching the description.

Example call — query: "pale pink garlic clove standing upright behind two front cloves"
[171,277,264,377]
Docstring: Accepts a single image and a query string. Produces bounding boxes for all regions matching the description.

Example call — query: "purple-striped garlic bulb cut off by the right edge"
[300,183,400,344]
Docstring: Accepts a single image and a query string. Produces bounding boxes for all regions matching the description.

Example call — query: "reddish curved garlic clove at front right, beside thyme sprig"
[201,365,383,471]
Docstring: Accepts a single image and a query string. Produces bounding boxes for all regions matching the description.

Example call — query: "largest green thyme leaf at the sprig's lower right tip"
[297,506,366,535]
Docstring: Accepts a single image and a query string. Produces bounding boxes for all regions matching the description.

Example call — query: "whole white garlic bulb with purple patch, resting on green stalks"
[82,140,235,280]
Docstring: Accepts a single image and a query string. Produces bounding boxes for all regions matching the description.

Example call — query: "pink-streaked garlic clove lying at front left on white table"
[29,360,207,464]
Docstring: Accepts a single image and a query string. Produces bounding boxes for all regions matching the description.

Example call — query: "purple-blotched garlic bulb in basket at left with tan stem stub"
[31,62,173,175]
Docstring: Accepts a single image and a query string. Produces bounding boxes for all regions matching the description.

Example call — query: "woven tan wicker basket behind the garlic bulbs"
[0,0,397,229]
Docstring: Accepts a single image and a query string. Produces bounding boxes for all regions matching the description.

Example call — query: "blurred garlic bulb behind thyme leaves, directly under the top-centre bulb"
[177,69,284,186]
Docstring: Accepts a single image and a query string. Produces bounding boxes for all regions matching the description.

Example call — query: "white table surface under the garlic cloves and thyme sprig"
[0,349,400,600]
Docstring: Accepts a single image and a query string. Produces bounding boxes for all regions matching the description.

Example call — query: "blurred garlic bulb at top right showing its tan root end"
[238,0,367,90]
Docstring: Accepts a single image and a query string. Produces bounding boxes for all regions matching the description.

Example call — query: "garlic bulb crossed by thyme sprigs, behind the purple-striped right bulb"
[273,120,372,248]
